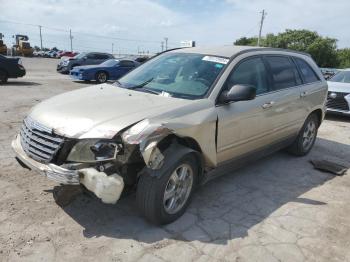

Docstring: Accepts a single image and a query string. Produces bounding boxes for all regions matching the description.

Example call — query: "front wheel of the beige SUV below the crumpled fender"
[136,154,198,225]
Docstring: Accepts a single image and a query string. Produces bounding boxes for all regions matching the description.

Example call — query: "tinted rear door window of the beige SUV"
[266,56,301,90]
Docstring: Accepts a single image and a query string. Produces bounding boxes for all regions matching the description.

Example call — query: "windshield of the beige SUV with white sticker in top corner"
[117,53,229,99]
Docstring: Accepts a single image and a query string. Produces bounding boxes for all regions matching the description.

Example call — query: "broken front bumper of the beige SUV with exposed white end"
[11,135,124,204]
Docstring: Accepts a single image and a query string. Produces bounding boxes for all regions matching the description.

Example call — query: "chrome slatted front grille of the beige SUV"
[20,117,64,163]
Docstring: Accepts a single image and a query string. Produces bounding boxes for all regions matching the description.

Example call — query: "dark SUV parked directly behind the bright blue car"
[57,52,114,74]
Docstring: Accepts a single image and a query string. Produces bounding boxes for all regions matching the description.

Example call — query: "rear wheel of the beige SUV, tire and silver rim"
[287,114,319,156]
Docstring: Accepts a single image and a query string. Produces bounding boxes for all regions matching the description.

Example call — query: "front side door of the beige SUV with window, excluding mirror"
[217,56,274,163]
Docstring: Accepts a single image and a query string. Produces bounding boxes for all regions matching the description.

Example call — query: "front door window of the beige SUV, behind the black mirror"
[226,57,269,95]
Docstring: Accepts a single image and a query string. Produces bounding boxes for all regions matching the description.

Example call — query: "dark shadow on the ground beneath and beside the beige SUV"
[58,139,350,244]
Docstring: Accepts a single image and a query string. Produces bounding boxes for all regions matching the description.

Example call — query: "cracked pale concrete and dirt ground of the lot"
[0,58,350,262]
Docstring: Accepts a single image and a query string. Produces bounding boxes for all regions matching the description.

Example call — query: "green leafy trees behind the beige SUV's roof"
[234,29,350,68]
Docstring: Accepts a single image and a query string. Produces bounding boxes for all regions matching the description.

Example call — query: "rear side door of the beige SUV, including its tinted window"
[264,55,305,140]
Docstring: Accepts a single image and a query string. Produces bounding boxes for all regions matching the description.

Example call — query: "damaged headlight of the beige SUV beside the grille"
[67,139,122,162]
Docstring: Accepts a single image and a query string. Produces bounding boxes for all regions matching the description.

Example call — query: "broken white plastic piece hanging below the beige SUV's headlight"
[80,168,124,204]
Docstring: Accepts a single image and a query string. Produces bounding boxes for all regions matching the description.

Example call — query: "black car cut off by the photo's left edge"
[0,55,26,84]
